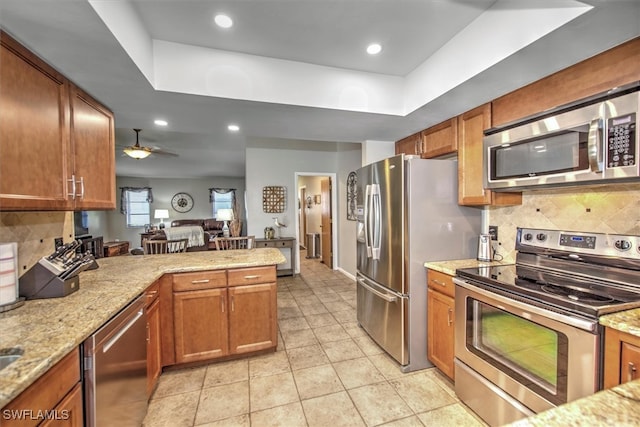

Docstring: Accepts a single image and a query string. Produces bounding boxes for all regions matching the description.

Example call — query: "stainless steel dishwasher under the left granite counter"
[83,296,147,427]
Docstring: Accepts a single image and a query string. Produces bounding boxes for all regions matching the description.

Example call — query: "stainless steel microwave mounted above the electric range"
[483,83,640,191]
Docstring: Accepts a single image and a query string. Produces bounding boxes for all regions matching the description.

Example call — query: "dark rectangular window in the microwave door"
[490,125,589,180]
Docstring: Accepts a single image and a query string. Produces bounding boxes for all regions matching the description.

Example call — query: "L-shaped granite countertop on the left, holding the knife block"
[0,248,286,408]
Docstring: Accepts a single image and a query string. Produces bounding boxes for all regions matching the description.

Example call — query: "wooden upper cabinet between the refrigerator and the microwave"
[458,104,522,206]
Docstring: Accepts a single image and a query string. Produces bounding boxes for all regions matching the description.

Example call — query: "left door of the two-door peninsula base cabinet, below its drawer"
[173,288,229,363]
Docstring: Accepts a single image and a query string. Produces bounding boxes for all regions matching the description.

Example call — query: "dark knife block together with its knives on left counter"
[19,240,98,299]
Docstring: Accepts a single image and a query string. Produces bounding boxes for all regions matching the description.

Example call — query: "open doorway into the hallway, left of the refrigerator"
[296,172,337,269]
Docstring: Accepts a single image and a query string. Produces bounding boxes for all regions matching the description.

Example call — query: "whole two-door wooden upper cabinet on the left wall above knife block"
[0,31,116,211]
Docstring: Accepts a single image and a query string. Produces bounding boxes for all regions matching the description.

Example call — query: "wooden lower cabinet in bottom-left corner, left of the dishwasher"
[0,349,84,427]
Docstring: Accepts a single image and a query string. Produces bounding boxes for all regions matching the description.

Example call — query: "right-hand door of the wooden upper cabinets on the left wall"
[71,85,116,209]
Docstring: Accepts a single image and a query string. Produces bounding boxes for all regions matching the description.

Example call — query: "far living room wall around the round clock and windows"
[102,176,246,248]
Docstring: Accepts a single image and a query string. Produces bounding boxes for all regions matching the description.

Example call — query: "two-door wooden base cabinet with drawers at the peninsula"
[171,266,278,363]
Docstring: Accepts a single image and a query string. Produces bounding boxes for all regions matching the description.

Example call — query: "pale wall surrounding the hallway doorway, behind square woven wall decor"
[246,142,361,274]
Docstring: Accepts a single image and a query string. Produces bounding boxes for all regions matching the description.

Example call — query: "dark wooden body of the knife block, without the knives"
[18,264,80,299]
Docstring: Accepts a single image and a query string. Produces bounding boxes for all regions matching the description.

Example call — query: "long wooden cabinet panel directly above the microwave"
[493,37,640,127]
